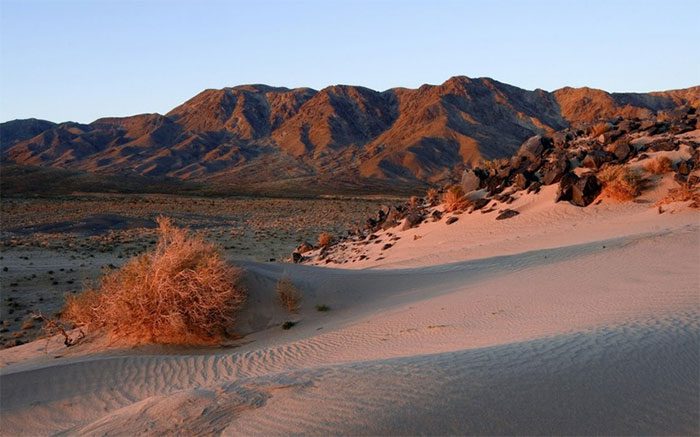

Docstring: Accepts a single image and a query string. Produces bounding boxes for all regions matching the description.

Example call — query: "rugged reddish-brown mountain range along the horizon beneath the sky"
[0,77,700,192]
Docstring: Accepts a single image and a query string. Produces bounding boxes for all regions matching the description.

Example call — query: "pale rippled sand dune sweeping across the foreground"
[0,175,700,435]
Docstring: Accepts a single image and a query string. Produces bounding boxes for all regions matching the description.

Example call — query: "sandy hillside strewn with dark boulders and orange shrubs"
[291,107,700,266]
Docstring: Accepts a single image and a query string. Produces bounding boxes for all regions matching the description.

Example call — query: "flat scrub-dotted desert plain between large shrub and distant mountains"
[0,194,388,347]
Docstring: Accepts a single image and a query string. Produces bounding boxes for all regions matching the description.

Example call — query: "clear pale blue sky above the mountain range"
[0,0,700,122]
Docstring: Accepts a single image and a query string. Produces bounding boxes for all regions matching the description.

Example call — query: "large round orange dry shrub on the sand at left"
[63,217,245,344]
